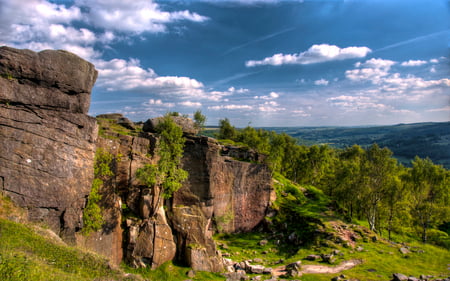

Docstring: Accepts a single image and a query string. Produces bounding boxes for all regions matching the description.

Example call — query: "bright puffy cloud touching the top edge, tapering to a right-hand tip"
[76,0,208,33]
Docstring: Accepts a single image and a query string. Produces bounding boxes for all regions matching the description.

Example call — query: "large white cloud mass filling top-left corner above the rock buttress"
[0,0,207,60]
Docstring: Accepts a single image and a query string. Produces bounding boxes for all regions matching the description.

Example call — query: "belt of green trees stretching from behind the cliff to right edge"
[217,119,450,248]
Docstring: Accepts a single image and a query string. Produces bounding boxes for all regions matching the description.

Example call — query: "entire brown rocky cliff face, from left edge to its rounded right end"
[0,47,273,271]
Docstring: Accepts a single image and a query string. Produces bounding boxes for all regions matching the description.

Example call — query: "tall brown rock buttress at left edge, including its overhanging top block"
[0,47,97,242]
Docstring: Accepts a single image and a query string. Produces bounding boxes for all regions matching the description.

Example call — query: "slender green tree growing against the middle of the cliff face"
[136,114,188,216]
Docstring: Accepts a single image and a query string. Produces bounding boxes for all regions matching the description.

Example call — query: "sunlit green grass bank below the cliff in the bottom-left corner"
[0,219,132,281]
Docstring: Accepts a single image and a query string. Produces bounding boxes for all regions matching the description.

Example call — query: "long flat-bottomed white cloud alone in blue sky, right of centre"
[245,44,371,67]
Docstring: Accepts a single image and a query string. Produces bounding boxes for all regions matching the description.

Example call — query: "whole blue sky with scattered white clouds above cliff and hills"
[0,0,450,127]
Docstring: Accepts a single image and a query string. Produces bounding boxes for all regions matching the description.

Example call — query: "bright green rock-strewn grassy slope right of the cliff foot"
[215,176,450,281]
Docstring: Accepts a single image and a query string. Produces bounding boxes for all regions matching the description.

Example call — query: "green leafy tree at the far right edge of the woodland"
[407,156,450,243]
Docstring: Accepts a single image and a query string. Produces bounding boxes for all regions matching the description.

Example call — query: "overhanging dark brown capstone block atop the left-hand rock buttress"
[0,47,97,113]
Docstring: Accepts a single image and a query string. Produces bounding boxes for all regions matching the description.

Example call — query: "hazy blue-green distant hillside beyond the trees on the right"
[264,122,450,169]
